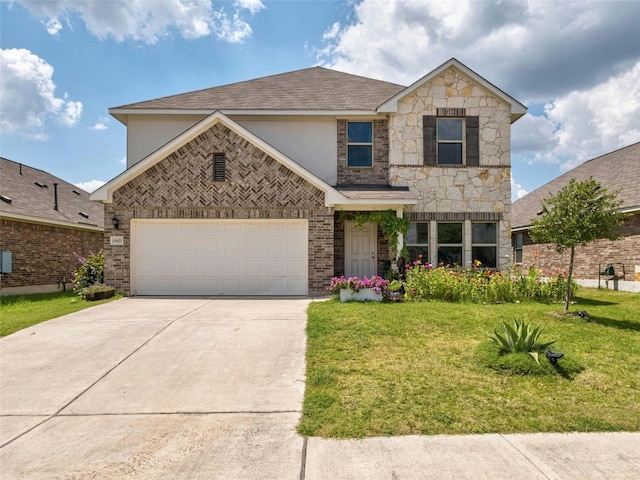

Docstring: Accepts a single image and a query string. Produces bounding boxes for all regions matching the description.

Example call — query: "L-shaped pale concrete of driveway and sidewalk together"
[0,298,640,480]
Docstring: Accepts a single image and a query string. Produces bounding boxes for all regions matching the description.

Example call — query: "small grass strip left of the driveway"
[0,291,118,337]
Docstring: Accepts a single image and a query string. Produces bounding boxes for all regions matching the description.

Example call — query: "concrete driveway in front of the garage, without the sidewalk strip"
[0,298,310,479]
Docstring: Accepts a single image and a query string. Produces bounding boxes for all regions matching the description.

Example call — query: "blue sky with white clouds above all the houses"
[0,0,640,198]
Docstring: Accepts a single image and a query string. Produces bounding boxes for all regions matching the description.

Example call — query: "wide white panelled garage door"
[131,220,308,295]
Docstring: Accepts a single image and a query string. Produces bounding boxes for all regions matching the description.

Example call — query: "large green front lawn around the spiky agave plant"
[298,288,640,438]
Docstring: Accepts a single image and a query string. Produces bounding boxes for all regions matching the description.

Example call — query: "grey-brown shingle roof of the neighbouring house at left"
[0,158,104,228]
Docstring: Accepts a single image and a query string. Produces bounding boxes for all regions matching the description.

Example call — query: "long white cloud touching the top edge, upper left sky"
[21,0,264,43]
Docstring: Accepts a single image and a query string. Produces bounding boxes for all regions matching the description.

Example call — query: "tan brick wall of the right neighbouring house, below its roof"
[513,214,640,281]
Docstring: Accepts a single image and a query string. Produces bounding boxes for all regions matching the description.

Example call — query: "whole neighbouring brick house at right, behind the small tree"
[511,143,640,292]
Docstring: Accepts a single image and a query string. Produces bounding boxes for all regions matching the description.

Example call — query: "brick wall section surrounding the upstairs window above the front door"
[338,120,389,185]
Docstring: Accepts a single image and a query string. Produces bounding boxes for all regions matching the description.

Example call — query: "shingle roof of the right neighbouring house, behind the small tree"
[511,143,640,229]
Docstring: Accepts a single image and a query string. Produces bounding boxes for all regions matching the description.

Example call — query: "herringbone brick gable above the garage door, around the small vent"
[114,125,324,209]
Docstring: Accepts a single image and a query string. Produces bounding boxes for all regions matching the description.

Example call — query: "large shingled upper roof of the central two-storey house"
[112,67,405,111]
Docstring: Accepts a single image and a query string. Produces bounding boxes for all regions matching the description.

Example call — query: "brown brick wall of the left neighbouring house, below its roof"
[0,219,103,288]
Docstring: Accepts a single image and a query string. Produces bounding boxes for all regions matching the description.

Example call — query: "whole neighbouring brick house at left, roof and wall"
[0,158,104,295]
